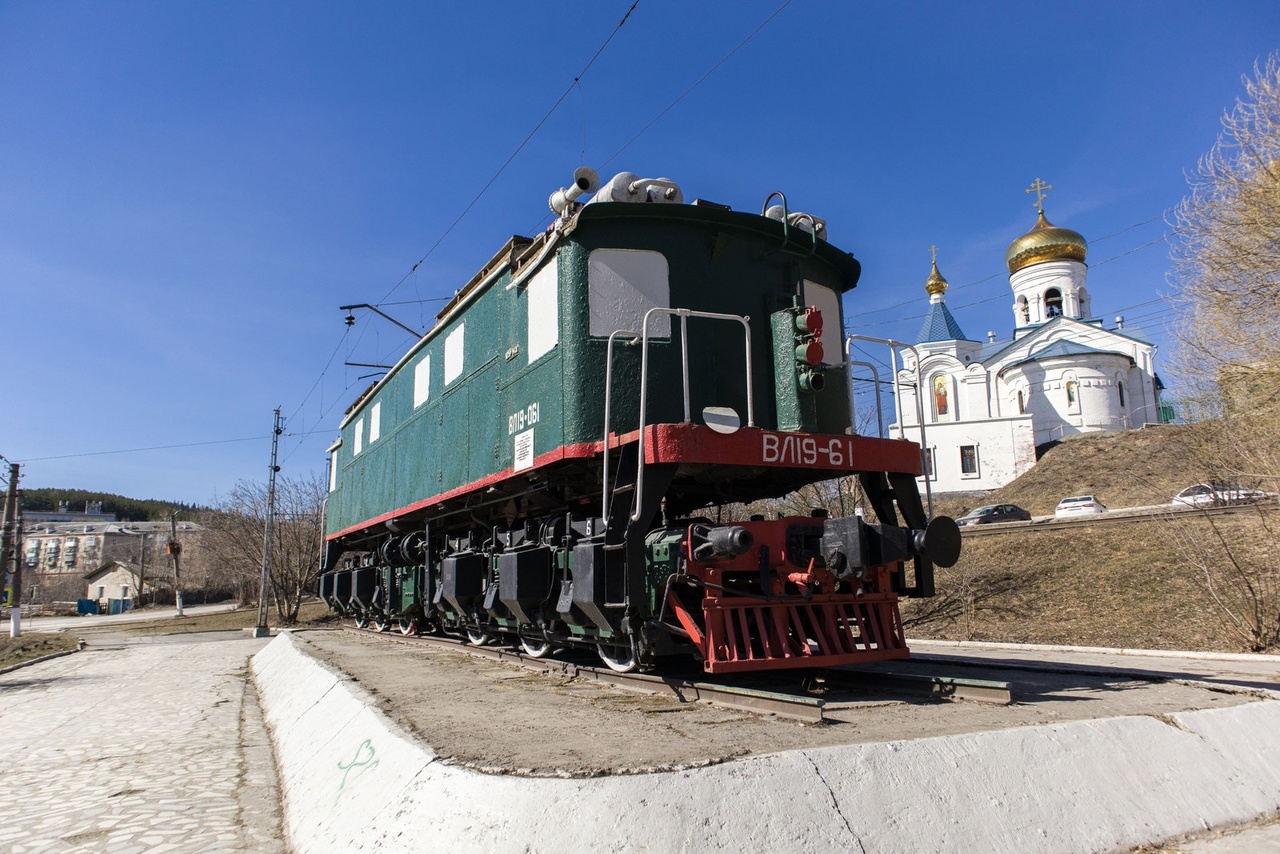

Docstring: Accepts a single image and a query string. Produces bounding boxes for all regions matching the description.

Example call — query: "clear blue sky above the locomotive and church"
[0,0,1280,503]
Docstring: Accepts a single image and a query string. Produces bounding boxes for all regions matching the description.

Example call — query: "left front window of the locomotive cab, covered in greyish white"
[588,250,671,338]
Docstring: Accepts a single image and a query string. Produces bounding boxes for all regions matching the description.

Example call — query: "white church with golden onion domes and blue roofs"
[891,186,1161,494]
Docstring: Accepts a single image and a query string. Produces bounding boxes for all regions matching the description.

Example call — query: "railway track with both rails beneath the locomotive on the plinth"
[343,626,1012,723]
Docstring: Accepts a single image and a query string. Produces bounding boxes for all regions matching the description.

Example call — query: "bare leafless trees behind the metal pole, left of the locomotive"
[202,476,325,624]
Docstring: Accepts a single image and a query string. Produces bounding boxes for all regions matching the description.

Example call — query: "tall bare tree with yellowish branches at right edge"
[1170,54,1280,650]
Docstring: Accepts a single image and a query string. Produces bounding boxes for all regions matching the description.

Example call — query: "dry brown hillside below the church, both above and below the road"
[902,425,1280,652]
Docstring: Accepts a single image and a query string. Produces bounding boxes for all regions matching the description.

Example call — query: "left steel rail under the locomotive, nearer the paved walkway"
[343,625,827,723]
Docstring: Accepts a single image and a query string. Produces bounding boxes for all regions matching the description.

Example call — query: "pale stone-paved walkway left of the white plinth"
[0,632,285,854]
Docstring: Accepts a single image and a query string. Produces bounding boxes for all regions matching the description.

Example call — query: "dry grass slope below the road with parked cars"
[902,512,1274,652]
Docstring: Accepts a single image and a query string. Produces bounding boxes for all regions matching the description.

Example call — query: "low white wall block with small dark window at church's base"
[906,415,1036,494]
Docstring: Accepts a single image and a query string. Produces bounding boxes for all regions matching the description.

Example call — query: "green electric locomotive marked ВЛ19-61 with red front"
[320,168,960,672]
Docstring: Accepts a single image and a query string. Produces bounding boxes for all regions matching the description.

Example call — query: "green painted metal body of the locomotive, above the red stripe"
[326,204,858,536]
